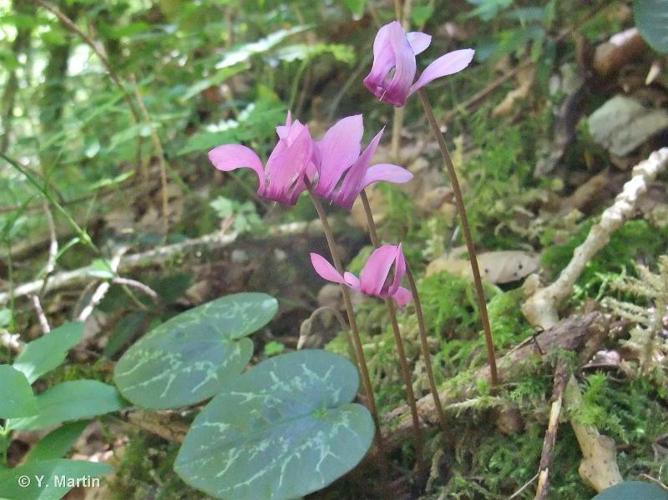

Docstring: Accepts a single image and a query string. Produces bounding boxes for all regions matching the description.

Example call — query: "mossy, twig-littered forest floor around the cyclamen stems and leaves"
[0,3,668,499]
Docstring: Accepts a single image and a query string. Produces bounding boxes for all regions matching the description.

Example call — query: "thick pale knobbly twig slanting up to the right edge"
[522,148,668,328]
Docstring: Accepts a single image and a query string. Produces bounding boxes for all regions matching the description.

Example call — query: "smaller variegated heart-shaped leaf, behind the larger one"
[114,293,278,409]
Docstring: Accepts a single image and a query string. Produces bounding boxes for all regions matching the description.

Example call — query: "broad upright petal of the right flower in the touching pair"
[315,115,364,197]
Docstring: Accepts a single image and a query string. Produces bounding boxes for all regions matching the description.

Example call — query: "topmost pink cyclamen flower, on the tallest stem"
[364,21,475,106]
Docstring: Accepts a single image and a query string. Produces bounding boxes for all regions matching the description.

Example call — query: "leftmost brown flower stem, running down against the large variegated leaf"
[309,190,384,446]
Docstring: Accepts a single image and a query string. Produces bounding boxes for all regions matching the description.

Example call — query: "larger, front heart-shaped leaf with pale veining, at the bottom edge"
[174,350,374,500]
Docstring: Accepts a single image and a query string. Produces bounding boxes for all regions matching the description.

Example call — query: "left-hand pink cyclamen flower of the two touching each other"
[209,113,315,205]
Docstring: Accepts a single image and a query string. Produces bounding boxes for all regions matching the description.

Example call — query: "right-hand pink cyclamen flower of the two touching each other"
[313,115,413,209]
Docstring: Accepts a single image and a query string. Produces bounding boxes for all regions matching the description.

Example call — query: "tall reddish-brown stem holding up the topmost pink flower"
[417,89,498,386]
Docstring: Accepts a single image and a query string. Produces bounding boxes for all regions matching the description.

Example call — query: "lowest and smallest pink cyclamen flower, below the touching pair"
[311,244,411,307]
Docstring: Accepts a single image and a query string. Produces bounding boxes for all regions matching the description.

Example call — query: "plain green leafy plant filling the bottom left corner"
[0,323,126,498]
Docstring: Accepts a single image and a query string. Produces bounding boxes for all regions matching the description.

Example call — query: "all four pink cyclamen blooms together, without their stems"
[209,21,474,306]
